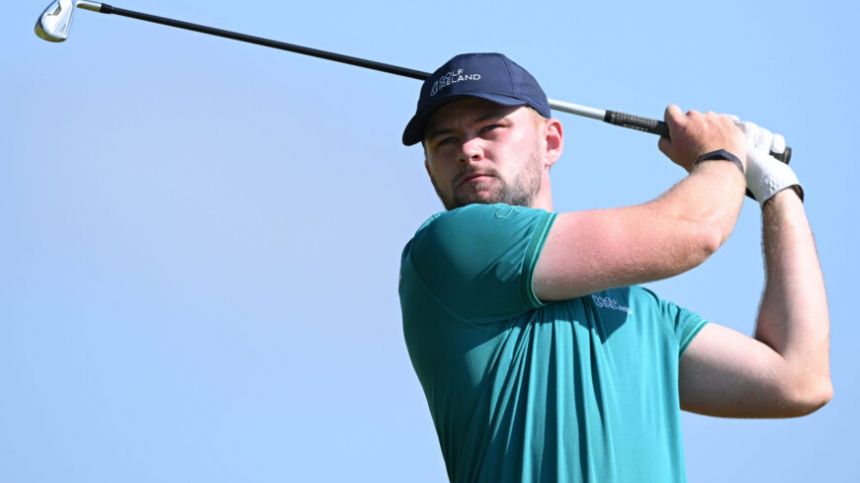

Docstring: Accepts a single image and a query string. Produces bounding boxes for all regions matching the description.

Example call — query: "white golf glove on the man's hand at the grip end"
[738,122,803,206]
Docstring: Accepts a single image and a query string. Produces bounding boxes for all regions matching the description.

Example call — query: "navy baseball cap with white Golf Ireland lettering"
[403,53,550,146]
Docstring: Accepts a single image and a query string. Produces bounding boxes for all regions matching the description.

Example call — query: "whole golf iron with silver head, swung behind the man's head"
[36,0,791,163]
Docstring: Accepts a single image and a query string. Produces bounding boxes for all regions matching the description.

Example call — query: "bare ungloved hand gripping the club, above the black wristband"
[658,105,747,173]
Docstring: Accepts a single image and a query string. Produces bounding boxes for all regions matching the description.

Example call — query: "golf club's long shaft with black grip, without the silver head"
[77,0,791,163]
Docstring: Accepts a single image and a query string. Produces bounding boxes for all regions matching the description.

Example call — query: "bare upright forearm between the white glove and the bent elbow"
[756,189,832,410]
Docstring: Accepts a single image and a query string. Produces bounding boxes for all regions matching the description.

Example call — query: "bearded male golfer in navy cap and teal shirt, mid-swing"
[400,54,832,482]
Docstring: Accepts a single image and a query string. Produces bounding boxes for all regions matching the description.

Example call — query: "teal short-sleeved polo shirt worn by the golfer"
[400,204,706,483]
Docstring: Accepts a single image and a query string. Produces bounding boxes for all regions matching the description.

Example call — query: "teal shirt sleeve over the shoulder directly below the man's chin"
[405,204,555,323]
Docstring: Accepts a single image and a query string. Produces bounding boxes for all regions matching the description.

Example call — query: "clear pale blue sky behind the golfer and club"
[0,0,860,483]
